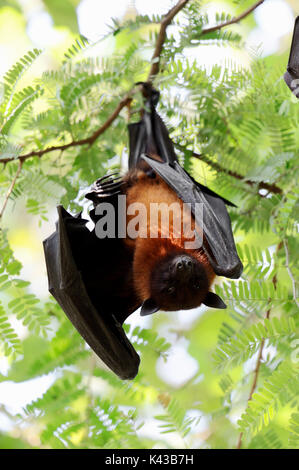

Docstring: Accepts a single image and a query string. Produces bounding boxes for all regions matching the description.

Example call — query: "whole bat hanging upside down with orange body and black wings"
[44,84,243,379]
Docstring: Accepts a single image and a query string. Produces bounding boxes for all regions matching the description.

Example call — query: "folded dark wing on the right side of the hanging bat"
[143,155,243,279]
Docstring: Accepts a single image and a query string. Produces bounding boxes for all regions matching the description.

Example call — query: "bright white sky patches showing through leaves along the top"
[15,0,294,81]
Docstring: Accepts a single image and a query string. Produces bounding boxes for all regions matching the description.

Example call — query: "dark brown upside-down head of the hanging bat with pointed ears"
[141,253,226,316]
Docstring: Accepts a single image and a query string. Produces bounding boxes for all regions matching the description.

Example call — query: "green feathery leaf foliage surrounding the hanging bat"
[0,0,299,448]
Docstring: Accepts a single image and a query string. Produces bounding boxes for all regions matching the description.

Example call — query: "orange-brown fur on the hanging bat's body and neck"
[125,170,215,301]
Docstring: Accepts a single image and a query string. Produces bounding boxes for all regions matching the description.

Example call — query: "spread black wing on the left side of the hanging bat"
[44,206,140,379]
